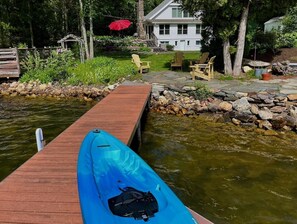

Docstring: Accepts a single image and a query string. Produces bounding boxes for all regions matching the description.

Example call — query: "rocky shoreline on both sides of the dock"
[0,81,297,132]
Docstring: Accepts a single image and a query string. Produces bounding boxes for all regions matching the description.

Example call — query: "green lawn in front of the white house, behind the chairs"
[101,52,200,71]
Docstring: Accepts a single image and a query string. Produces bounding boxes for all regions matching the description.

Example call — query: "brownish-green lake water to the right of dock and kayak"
[139,113,297,223]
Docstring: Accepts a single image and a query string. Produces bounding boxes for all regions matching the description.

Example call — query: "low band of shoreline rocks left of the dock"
[0,81,114,101]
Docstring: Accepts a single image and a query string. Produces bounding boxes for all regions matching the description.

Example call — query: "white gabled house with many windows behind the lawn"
[144,0,202,51]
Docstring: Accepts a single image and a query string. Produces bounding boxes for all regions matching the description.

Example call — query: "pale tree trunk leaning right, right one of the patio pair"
[233,2,250,76]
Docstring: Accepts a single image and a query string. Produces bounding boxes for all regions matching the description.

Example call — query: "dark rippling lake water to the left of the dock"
[0,97,92,181]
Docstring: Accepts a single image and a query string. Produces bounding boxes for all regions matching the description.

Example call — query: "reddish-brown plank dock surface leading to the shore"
[0,85,151,224]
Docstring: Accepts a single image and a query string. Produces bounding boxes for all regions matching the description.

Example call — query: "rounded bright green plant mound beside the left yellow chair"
[68,57,136,85]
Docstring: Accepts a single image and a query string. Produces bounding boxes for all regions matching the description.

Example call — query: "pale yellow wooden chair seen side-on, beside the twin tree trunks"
[190,56,216,81]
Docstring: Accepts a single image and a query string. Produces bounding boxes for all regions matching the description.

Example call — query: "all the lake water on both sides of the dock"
[0,97,297,224]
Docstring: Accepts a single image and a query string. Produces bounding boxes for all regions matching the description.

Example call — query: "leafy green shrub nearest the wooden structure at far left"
[20,51,75,83]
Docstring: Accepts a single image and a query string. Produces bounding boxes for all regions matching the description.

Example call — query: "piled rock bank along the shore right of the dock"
[151,84,297,131]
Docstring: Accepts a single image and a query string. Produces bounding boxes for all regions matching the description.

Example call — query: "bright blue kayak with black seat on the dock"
[77,129,198,224]
